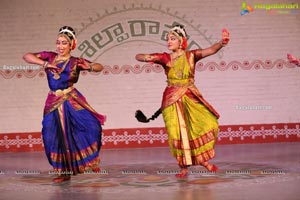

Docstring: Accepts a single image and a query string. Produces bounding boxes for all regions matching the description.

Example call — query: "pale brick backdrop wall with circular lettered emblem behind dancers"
[0,0,300,133]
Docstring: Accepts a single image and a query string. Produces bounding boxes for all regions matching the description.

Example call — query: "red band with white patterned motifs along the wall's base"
[0,122,300,152]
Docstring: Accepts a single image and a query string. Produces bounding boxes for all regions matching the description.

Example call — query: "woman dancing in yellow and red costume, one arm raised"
[136,25,229,177]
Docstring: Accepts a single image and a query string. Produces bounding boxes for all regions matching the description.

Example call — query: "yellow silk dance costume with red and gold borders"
[161,54,219,167]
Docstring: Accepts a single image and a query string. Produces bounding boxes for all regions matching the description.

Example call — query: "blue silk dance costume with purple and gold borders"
[38,52,105,175]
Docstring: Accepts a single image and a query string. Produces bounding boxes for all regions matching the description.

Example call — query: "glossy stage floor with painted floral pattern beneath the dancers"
[0,143,300,200]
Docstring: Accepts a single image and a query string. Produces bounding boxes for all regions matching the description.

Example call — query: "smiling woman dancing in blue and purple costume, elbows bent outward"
[23,26,105,183]
